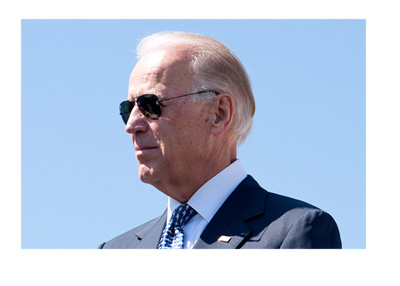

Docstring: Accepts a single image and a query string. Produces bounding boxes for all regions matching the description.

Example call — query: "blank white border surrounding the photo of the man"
[0,0,400,285]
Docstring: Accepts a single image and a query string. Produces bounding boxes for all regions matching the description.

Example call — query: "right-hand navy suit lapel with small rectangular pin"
[194,176,267,249]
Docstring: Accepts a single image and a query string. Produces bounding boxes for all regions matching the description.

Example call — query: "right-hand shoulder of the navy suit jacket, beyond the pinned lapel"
[236,176,341,248]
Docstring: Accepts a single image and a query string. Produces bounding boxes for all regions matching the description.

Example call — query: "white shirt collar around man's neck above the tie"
[167,159,247,222]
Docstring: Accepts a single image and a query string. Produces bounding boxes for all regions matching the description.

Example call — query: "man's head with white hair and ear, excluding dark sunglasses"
[122,30,255,202]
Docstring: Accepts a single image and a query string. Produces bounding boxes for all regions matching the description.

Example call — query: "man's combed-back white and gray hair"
[136,32,255,144]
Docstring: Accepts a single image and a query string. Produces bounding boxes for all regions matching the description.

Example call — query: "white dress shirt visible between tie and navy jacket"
[167,159,247,249]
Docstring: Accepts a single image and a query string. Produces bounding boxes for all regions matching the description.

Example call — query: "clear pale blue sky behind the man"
[21,20,366,249]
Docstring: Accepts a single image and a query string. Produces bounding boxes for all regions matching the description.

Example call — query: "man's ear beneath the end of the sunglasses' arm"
[210,94,235,135]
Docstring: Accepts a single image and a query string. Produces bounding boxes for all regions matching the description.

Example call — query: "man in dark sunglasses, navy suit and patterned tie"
[99,32,341,249]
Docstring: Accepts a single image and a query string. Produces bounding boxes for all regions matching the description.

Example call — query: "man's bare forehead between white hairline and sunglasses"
[129,50,192,96]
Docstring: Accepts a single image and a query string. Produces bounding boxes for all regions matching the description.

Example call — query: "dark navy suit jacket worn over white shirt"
[99,176,342,249]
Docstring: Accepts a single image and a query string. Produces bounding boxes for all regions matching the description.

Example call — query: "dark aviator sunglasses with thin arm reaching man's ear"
[119,89,219,124]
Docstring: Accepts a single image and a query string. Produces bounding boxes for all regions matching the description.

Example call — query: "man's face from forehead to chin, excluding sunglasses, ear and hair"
[126,51,214,197]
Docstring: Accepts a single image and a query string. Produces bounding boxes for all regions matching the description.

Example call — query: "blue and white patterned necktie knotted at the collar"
[158,204,196,249]
